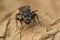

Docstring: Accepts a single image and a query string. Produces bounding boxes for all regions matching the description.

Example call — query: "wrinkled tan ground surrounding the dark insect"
[0,0,60,40]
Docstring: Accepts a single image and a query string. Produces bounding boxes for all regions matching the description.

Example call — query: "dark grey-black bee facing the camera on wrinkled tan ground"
[16,6,38,24]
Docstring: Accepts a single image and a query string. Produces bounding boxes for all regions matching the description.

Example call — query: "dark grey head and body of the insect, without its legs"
[20,6,32,23]
